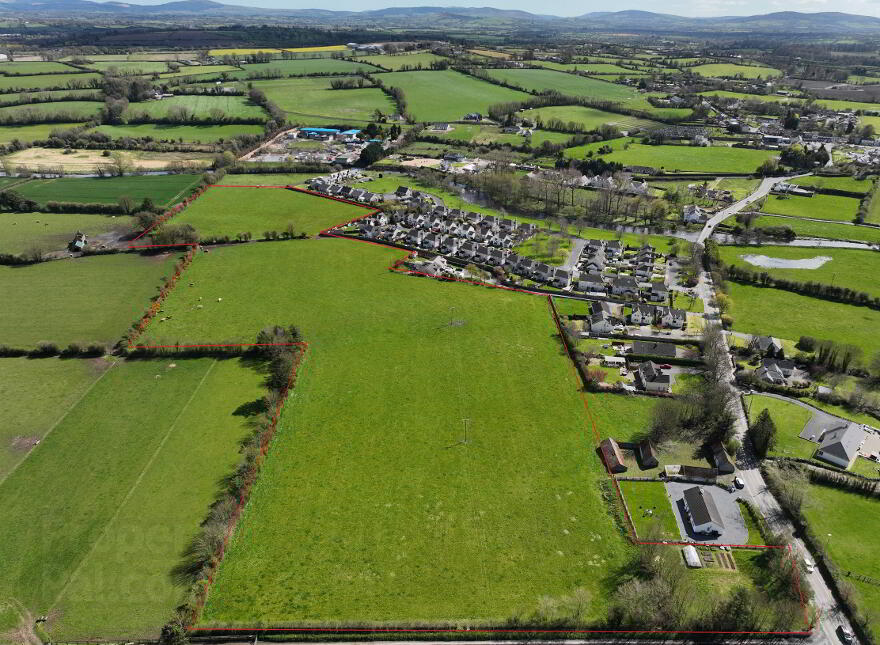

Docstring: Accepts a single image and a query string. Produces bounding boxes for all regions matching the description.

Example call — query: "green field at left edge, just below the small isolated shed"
[0,253,178,347]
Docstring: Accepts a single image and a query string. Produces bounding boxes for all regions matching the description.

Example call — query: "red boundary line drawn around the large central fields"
[129,184,818,636]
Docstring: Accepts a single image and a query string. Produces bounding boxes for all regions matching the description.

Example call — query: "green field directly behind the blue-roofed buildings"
[253,78,397,125]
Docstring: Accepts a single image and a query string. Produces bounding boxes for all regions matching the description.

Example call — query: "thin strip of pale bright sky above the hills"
[125,0,880,17]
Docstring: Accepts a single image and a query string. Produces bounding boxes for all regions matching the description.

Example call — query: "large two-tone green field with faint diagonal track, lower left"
[0,359,265,640]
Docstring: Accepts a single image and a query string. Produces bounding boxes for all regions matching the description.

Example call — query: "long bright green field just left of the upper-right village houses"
[565,139,776,174]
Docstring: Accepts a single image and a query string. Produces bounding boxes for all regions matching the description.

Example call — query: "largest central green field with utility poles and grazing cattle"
[148,239,629,625]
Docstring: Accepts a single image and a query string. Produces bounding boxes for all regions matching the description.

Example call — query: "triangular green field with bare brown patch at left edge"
[0,358,109,483]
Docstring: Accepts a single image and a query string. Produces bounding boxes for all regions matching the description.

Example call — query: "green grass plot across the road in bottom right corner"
[803,484,880,634]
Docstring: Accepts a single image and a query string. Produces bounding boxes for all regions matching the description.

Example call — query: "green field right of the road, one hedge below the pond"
[728,282,880,356]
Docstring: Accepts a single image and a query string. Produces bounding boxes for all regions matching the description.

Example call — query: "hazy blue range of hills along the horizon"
[0,0,880,35]
